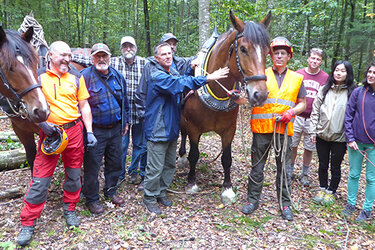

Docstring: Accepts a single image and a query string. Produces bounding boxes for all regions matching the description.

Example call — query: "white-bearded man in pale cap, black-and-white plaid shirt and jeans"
[72,36,148,190]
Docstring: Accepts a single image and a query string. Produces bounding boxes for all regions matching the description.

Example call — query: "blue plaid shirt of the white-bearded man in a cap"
[81,66,129,126]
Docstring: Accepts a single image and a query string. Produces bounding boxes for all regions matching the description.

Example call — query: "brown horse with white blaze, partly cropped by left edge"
[0,26,50,170]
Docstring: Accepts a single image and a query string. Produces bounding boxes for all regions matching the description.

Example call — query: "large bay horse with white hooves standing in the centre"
[179,12,271,204]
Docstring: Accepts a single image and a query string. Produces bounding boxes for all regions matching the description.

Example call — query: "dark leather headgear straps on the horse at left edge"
[0,58,42,119]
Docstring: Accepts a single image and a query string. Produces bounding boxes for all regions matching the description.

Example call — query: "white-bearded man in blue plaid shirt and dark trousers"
[82,43,129,214]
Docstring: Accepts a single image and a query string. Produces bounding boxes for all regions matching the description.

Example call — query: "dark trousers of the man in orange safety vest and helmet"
[247,133,292,207]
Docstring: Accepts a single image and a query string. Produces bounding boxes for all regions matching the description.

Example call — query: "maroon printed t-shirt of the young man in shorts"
[297,68,328,118]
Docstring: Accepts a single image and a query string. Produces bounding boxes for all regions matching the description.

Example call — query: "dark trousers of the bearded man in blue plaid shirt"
[82,123,122,204]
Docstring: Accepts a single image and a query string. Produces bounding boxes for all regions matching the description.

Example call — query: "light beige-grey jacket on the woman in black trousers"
[309,85,348,142]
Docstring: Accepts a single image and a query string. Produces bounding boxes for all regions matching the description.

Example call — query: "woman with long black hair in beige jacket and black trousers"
[309,61,356,205]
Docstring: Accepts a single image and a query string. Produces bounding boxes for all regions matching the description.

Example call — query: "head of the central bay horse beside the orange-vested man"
[229,11,271,106]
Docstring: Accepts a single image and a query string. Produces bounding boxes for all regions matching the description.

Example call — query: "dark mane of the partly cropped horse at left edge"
[0,30,38,73]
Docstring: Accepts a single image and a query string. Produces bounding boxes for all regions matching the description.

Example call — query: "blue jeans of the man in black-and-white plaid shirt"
[120,123,147,178]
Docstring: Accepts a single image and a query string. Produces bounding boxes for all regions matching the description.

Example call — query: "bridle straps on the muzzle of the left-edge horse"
[0,63,42,119]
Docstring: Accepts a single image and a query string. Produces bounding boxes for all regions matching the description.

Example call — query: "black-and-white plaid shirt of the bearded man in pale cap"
[72,54,148,124]
